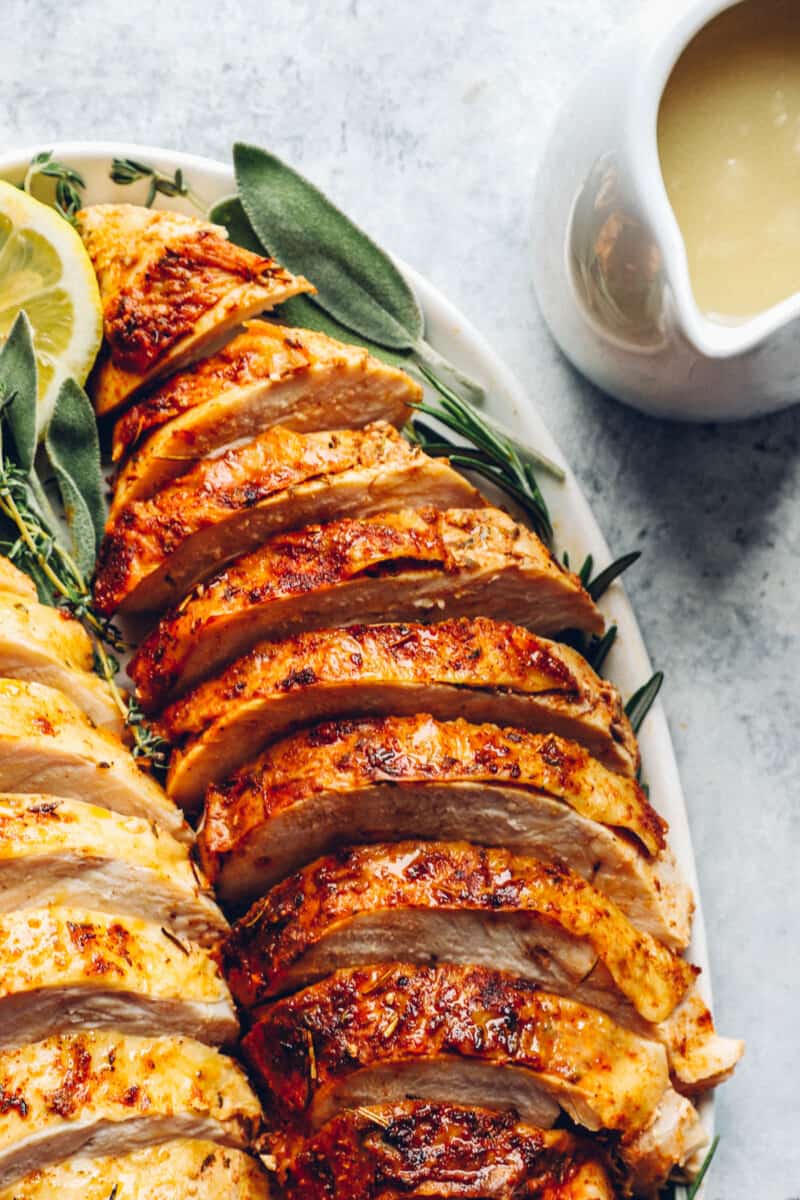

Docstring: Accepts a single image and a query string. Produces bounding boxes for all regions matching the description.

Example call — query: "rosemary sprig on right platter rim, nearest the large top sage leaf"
[410,364,553,542]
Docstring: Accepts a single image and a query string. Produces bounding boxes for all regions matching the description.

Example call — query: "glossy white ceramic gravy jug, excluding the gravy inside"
[534,0,800,421]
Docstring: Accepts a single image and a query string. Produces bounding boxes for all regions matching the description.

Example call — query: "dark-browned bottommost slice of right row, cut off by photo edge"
[275,1100,616,1200]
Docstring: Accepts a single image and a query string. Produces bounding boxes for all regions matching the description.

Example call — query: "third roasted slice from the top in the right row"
[95,421,485,614]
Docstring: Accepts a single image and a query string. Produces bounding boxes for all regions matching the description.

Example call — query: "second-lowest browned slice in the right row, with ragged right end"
[242,964,704,1177]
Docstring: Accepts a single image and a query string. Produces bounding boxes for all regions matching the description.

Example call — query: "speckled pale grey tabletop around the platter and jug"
[0,0,800,1200]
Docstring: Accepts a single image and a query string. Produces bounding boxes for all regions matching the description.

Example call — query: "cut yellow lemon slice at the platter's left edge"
[0,180,103,428]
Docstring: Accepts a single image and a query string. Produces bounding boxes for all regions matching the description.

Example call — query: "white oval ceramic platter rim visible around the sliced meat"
[0,142,714,1152]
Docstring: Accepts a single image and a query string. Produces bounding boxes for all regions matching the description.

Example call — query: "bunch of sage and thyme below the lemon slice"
[0,312,168,768]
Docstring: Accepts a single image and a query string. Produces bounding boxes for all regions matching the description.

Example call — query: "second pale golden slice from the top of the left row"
[0,586,125,736]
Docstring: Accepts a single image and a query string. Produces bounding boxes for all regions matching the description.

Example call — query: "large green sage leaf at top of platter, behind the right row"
[234,142,423,350]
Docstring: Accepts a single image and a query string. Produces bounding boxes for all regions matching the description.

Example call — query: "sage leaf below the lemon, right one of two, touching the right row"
[44,379,106,576]
